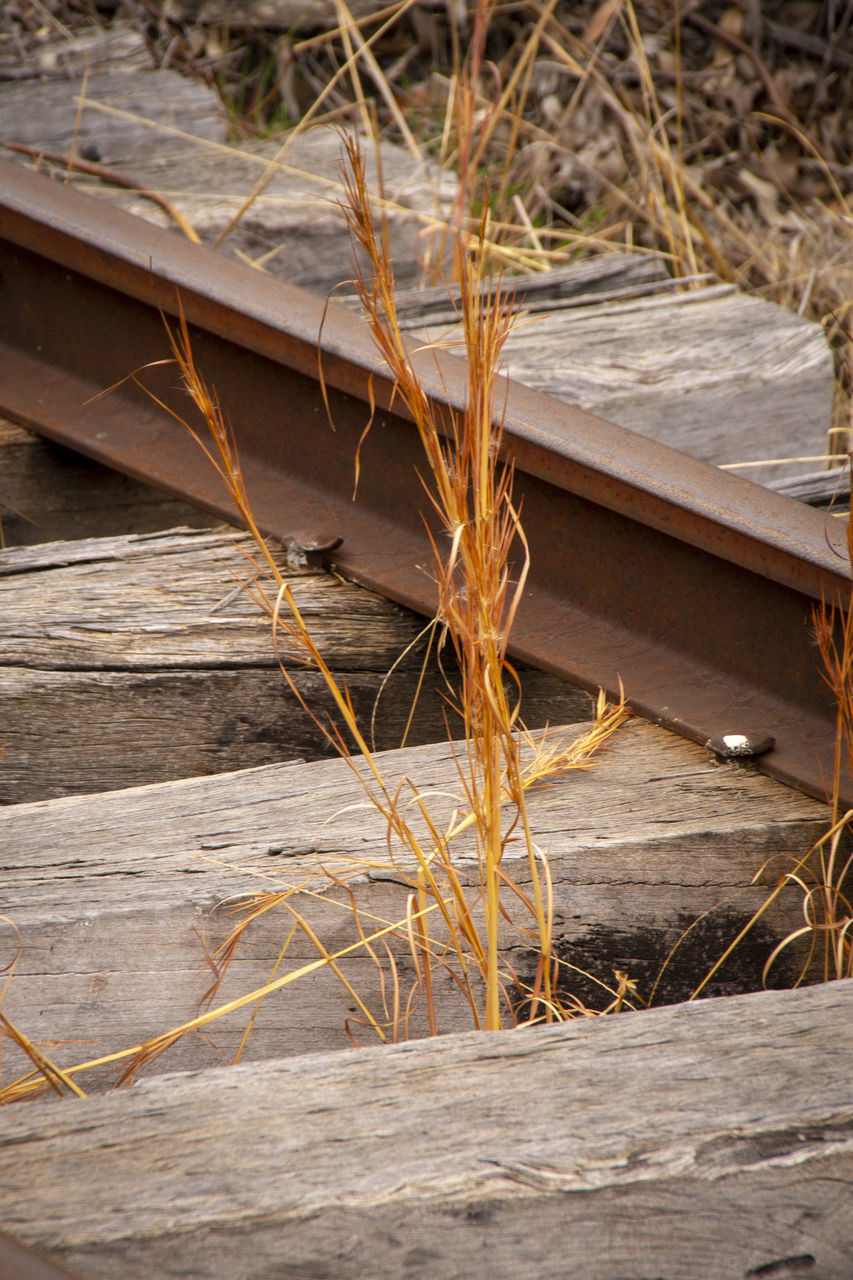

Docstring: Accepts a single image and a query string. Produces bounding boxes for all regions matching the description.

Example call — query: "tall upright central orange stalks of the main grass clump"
[333,127,630,1029]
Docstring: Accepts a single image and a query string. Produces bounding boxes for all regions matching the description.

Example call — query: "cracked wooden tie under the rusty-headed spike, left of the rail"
[0,529,592,804]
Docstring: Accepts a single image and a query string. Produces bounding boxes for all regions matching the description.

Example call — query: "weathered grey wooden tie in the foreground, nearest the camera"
[0,982,853,1280]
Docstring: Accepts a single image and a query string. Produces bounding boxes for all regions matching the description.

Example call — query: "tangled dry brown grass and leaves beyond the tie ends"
[0,0,853,427]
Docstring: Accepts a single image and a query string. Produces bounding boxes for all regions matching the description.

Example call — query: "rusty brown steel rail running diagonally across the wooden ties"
[0,164,853,804]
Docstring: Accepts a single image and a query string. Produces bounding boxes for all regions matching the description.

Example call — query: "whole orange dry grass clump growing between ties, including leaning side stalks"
[0,122,631,1102]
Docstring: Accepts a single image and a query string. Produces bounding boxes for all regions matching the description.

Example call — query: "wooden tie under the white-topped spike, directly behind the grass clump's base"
[0,721,827,1087]
